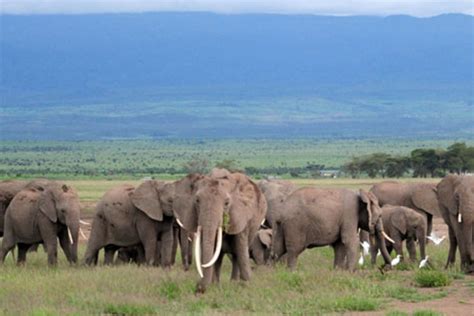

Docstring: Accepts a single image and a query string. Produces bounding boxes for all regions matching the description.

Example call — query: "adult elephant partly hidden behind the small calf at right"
[370,181,440,239]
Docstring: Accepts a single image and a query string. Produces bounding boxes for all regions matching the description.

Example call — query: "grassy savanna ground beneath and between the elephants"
[0,179,474,315]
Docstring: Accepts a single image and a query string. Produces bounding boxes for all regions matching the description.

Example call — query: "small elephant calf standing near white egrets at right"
[370,205,427,264]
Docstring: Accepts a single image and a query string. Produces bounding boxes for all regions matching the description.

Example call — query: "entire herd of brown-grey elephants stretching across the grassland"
[0,169,474,292]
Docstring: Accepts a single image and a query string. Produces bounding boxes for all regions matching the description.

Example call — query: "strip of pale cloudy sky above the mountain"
[0,0,474,17]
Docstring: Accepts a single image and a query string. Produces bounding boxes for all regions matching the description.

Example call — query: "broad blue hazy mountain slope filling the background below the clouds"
[0,13,474,139]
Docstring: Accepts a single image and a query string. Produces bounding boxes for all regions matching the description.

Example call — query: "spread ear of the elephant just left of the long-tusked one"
[131,180,163,221]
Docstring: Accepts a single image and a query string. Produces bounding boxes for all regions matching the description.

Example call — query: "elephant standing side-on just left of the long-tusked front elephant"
[84,180,174,267]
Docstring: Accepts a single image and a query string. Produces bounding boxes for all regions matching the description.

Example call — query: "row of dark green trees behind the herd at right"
[341,143,474,178]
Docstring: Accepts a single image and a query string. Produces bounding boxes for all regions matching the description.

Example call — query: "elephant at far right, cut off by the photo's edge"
[437,174,474,273]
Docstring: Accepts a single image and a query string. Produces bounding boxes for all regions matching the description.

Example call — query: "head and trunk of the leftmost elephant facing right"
[38,183,81,262]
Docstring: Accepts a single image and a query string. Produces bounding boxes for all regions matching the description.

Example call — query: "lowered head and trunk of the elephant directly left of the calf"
[359,190,392,265]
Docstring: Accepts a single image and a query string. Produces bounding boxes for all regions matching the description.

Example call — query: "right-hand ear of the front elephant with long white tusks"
[224,176,265,235]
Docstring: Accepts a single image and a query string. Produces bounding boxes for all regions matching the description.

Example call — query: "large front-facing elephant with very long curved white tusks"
[173,169,267,293]
